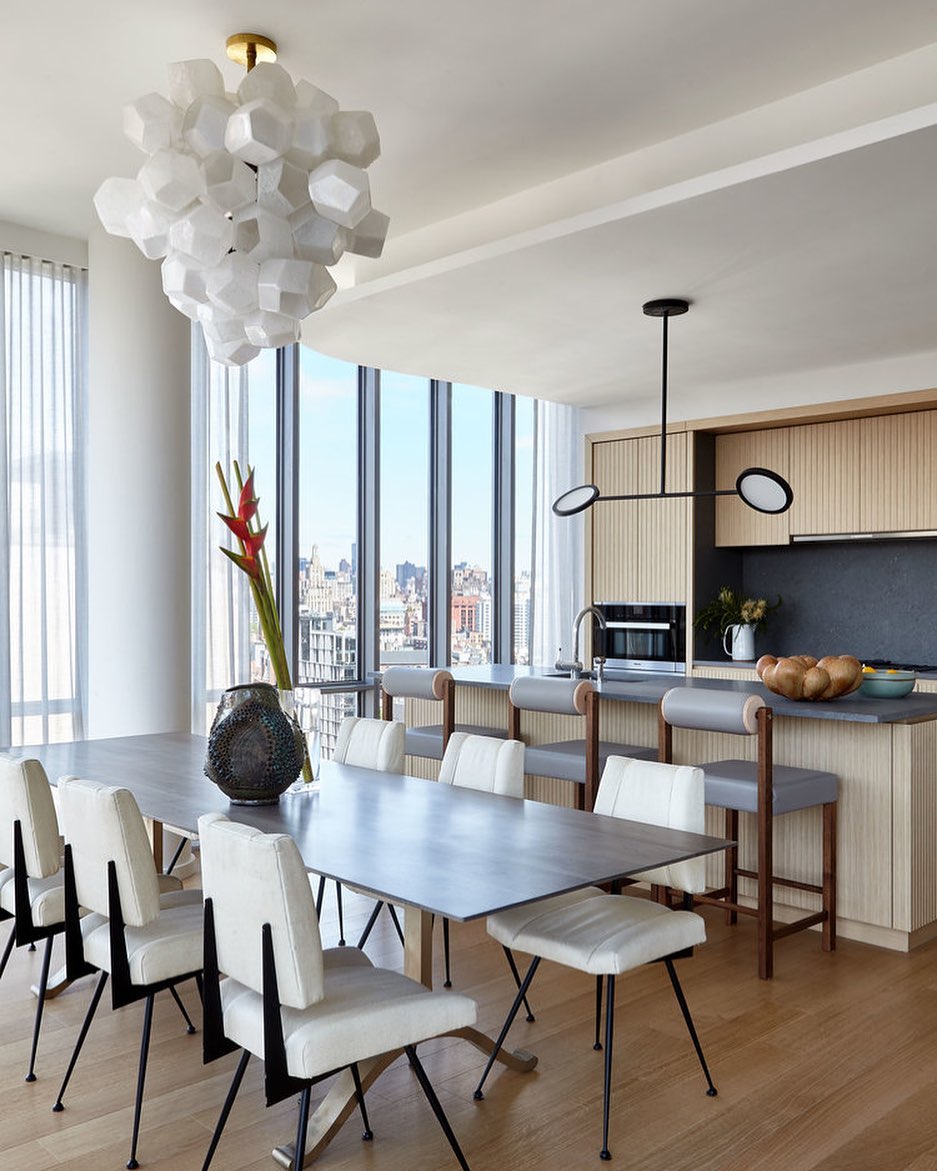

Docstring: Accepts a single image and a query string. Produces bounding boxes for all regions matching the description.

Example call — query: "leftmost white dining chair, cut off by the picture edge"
[0,756,66,1082]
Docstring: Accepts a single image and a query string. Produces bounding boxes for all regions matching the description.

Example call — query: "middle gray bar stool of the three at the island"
[507,676,654,810]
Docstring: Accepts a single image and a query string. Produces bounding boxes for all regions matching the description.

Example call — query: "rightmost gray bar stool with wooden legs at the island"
[658,687,839,980]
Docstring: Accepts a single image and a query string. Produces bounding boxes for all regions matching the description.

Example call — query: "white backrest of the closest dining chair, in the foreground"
[198,813,324,1008]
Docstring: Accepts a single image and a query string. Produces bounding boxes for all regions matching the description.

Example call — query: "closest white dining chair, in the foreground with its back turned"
[199,814,476,1171]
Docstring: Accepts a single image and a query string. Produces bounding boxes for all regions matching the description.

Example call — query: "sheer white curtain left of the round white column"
[0,252,86,745]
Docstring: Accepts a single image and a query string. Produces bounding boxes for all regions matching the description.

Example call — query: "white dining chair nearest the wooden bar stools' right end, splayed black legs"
[476,756,716,1159]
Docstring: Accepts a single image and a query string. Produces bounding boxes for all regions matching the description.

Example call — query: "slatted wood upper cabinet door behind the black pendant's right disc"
[716,427,798,546]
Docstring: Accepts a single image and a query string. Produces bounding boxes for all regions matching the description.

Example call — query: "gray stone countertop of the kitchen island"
[452,664,937,724]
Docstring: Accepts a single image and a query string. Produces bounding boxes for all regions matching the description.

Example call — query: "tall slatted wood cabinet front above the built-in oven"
[590,432,689,602]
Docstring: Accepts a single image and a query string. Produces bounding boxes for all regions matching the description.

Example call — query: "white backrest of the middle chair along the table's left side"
[59,776,159,927]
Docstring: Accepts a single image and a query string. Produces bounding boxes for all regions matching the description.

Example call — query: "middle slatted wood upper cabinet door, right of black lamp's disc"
[788,419,862,536]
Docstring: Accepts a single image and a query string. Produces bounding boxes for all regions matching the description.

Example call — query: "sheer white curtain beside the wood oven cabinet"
[531,400,586,666]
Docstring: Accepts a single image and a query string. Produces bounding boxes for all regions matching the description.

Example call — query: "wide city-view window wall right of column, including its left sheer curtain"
[193,336,533,735]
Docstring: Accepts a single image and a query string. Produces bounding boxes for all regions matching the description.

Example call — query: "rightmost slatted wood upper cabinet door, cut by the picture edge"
[860,411,937,533]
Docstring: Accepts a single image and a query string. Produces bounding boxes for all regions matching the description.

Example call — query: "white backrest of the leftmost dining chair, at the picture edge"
[0,756,60,878]
